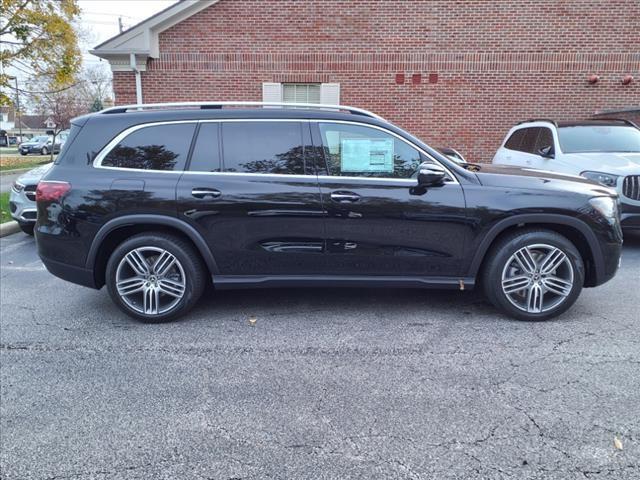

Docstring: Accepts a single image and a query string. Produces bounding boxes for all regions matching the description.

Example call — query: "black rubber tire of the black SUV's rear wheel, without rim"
[105,232,208,323]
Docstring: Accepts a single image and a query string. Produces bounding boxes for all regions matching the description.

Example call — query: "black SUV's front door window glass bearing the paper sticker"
[319,123,420,178]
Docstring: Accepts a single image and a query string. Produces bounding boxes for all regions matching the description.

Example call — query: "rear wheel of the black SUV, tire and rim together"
[106,233,206,323]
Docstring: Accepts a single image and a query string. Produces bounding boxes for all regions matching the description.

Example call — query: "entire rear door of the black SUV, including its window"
[177,121,324,275]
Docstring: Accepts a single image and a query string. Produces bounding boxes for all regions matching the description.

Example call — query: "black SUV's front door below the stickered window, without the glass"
[319,177,469,276]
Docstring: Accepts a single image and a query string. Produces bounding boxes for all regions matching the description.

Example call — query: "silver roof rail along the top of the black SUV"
[99,102,385,121]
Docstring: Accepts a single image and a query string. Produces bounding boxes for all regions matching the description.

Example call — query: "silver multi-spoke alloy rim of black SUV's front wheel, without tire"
[501,244,574,313]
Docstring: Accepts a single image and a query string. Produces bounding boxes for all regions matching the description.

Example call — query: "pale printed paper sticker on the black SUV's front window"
[340,138,393,173]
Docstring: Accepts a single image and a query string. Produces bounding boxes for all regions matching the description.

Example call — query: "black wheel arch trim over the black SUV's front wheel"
[469,214,604,287]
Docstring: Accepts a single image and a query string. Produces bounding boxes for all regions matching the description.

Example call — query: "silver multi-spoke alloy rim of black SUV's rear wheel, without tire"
[116,247,186,315]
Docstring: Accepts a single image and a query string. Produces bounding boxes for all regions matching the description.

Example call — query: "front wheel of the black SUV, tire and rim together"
[483,230,584,320]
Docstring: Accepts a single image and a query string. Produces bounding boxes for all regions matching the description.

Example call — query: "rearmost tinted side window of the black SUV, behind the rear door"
[102,123,196,170]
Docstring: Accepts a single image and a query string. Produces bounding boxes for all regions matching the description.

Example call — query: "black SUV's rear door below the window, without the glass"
[178,173,324,275]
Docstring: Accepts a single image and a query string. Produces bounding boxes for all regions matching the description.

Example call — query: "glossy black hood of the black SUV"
[475,164,616,196]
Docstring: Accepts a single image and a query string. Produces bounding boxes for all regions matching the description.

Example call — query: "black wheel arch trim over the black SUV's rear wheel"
[85,215,219,288]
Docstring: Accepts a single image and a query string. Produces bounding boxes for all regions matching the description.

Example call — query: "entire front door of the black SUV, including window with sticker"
[312,122,470,276]
